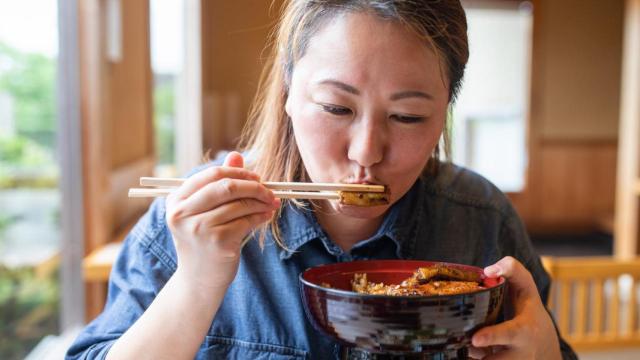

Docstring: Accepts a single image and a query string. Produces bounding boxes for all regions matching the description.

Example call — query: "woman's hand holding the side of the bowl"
[469,256,561,360]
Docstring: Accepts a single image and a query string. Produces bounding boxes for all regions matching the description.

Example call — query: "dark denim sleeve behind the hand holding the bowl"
[501,209,578,360]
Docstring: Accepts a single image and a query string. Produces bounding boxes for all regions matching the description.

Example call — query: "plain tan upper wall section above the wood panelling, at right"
[532,0,624,141]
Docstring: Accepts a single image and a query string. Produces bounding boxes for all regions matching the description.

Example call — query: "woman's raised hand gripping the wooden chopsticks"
[166,152,280,292]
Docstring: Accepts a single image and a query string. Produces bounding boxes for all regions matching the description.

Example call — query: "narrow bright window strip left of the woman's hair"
[150,0,202,176]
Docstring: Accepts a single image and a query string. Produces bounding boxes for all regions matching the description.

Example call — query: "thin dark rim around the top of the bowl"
[298,259,507,300]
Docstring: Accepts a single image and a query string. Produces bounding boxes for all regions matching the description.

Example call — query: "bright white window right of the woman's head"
[452,1,533,192]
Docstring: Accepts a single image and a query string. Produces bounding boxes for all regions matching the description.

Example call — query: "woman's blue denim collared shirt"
[67,164,576,359]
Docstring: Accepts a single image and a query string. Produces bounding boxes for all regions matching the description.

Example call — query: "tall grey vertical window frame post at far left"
[56,0,85,333]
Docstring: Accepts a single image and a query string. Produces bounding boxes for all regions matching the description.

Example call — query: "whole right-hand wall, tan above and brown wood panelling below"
[511,0,624,232]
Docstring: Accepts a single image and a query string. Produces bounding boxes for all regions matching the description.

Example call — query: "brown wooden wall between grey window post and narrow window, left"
[78,0,155,320]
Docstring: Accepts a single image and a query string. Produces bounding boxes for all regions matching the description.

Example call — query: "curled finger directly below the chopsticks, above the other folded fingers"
[176,178,279,216]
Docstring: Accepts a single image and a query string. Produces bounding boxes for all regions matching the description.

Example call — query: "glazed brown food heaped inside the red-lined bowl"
[351,264,483,296]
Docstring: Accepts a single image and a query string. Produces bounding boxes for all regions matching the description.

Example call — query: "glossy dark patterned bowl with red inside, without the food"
[300,260,506,354]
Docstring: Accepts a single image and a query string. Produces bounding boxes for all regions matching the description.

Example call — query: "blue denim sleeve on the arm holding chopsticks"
[66,200,175,359]
